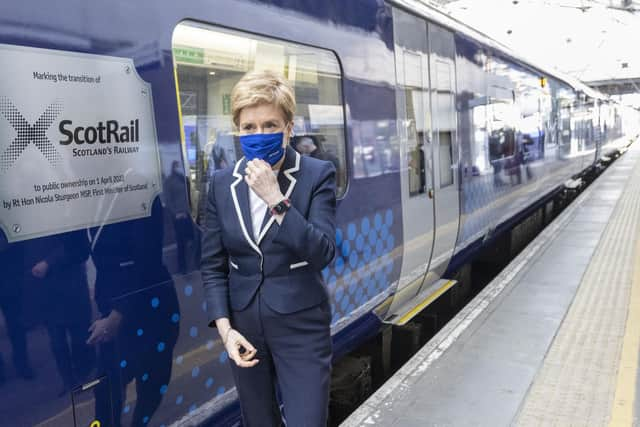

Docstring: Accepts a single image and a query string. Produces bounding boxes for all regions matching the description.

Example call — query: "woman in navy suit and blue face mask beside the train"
[202,71,336,427]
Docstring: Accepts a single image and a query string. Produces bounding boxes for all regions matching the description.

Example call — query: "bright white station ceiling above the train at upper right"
[424,0,640,100]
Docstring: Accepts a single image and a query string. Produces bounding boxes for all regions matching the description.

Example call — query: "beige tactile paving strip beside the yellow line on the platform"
[517,147,640,427]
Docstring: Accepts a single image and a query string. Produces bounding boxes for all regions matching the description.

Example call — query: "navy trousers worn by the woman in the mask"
[230,290,332,427]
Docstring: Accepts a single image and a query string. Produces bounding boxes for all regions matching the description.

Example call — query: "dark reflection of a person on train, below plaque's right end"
[87,198,180,427]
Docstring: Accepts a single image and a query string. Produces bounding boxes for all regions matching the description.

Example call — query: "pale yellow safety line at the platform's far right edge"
[609,234,640,427]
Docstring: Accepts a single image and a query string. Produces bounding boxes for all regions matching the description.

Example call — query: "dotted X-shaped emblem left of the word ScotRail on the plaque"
[0,96,64,172]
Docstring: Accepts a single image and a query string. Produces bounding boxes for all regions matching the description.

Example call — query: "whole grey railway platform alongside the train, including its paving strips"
[342,143,640,427]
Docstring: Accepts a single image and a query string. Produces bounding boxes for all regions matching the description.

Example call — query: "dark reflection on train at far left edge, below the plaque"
[0,230,95,425]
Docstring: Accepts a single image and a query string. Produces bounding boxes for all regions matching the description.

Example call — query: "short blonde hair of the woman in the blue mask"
[231,70,296,126]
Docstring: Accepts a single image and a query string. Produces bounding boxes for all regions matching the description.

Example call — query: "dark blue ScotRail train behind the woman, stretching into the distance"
[0,0,640,427]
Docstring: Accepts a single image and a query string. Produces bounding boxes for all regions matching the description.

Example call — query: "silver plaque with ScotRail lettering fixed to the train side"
[0,44,161,242]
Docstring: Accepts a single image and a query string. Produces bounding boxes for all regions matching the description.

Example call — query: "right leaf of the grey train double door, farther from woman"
[424,23,460,286]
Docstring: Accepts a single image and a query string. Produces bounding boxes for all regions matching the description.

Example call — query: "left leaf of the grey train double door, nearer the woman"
[389,5,434,313]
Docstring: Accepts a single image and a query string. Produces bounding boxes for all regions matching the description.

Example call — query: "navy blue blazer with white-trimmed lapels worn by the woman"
[201,147,336,326]
